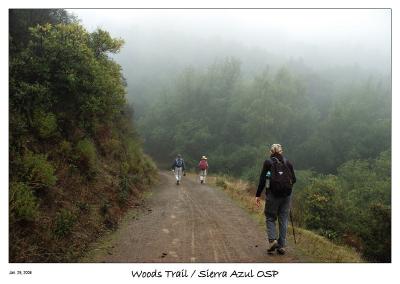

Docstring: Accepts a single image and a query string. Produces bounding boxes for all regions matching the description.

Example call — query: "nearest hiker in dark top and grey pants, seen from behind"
[256,144,296,254]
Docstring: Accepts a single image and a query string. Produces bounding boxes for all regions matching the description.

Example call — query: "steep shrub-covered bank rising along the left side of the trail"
[9,10,155,261]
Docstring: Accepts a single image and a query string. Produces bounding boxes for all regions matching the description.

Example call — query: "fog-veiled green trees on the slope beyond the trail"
[140,58,391,174]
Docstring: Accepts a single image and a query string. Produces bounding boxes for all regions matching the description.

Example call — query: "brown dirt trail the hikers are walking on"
[86,172,296,262]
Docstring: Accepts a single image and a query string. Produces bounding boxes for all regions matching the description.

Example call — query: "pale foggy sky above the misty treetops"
[68,9,391,110]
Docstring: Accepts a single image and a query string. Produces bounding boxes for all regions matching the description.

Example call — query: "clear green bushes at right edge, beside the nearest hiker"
[293,151,391,262]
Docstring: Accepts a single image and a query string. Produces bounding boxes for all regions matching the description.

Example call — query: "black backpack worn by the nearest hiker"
[269,157,293,197]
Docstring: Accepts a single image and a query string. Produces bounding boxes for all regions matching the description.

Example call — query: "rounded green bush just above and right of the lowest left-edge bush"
[22,152,57,188]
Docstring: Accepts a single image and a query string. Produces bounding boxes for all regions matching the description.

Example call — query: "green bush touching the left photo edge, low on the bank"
[10,182,39,221]
